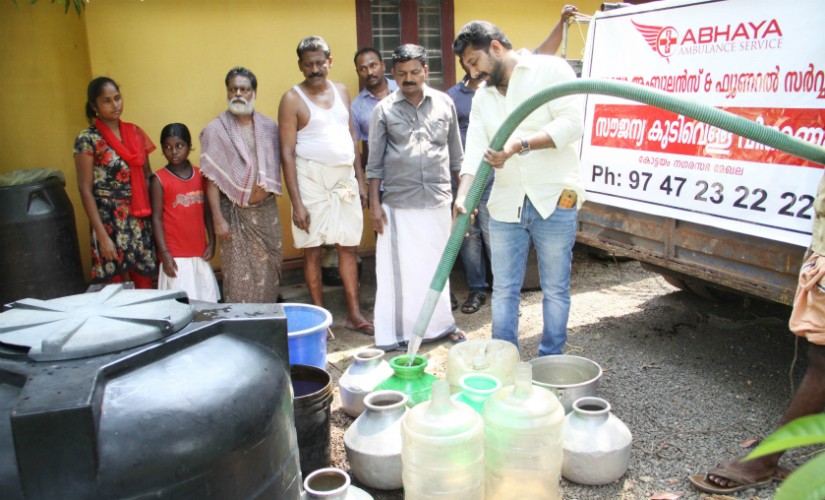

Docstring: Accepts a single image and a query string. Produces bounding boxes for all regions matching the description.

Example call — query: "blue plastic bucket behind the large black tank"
[281,304,332,370]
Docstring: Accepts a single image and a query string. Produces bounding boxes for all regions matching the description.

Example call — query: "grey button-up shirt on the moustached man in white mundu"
[367,85,463,208]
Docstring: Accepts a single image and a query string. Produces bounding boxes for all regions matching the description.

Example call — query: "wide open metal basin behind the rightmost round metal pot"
[530,354,602,413]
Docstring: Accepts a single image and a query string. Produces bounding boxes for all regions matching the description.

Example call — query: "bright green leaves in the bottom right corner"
[745,413,825,500]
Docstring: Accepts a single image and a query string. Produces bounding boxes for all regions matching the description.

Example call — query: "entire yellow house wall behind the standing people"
[0,0,600,284]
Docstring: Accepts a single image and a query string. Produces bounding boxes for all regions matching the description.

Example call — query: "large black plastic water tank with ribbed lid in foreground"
[0,285,302,499]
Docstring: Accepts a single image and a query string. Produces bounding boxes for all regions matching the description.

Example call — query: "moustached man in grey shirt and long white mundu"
[367,45,466,349]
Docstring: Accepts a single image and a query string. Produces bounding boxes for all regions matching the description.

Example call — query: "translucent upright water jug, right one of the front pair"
[483,363,564,500]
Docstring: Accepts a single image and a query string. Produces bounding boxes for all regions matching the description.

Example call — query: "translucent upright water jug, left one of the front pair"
[401,380,486,500]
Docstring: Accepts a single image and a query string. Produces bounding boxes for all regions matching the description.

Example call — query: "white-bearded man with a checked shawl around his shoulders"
[200,67,283,303]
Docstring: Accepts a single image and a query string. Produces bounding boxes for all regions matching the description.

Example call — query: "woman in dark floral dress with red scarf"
[74,77,157,288]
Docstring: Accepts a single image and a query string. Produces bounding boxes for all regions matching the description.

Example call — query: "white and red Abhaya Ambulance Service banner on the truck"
[582,0,825,246]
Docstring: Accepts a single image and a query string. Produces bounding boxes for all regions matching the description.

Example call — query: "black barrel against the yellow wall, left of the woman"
[0,169,84,305]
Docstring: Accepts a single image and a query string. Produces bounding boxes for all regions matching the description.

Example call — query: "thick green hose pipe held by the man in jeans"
[409,79,825,354]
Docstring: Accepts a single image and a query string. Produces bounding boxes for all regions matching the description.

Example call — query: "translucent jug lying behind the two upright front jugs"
[447,339,519,393]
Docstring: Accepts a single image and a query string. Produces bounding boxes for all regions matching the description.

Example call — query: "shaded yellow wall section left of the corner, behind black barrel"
[0,0,91,276]
